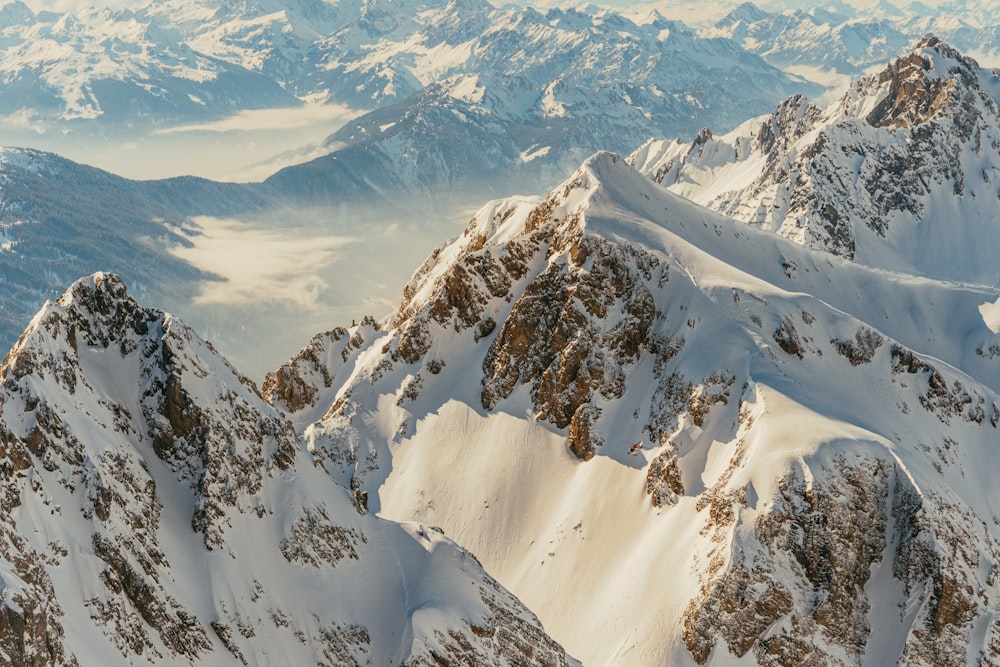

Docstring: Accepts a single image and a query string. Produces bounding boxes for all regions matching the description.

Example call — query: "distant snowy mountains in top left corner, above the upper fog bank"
[0,1,299,129]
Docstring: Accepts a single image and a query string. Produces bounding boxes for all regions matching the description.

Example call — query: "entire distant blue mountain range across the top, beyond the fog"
[0,0,820,197]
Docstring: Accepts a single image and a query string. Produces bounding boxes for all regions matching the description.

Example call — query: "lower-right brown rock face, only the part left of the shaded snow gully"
[685,461,891,665]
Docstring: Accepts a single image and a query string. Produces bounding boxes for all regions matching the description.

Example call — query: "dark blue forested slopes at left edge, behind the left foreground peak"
[0,148,288,378]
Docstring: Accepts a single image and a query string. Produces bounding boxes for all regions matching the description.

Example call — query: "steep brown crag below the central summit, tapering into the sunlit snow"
[482,230,662,459]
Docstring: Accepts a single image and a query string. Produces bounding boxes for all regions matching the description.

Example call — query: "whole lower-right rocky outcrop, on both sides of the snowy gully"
[684,456,996,666]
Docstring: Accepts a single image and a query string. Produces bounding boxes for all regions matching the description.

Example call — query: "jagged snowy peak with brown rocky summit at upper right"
[630,37,1000,285]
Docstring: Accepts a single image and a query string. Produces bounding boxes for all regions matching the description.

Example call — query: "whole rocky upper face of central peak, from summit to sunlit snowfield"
[304,154,744,476]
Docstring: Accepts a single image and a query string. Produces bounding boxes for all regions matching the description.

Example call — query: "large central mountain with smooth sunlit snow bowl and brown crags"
[264,154,1000,665]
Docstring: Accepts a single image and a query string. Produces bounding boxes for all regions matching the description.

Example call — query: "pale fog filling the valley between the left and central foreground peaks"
[164,203,474,382]
